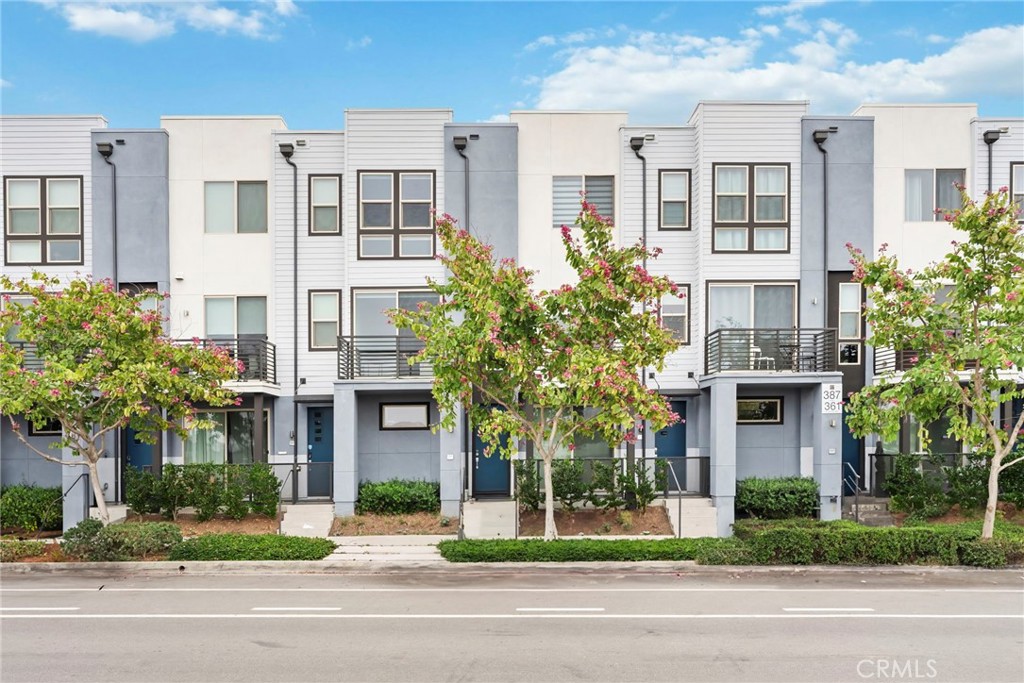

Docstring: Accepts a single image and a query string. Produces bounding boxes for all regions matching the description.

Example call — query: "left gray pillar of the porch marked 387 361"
[711,381,736,537]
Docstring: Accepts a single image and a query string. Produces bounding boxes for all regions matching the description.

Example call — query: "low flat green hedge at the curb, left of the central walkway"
[170,533,335,561]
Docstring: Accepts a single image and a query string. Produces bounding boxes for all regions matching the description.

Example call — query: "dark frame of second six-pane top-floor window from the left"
[355,169,437,261]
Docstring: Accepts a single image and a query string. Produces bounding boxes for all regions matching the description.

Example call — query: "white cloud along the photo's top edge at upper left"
[42,0,299,43]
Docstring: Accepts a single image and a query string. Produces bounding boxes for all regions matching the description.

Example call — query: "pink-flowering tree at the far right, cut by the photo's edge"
[847,187,1024,539]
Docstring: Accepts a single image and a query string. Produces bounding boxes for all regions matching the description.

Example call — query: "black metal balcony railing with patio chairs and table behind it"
[705,328,838,375]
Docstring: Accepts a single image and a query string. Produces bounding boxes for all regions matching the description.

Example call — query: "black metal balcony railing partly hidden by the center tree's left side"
[338,335,433,380]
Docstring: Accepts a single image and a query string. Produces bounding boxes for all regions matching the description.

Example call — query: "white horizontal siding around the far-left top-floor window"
[0,116,106,279]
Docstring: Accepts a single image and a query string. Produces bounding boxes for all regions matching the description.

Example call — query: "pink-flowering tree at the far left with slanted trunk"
[0,273,239,521]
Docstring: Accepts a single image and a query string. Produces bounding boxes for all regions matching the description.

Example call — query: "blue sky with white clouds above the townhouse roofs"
[0,0,1024,129]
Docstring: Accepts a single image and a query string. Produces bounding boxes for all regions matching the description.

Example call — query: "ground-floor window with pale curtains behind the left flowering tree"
[182,410,270,465]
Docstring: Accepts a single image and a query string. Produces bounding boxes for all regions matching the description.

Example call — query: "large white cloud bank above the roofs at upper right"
[536,22,1024,123]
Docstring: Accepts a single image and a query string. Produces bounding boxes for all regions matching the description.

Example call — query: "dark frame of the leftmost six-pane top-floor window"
[3,175,85,266]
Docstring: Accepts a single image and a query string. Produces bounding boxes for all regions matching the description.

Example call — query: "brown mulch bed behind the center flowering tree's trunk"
[519,506,672,537]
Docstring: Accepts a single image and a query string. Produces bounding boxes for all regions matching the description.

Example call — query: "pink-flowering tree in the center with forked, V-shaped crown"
[392,202,679,540]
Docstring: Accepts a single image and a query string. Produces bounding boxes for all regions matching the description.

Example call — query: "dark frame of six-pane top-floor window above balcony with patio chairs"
[712,162,793,254]
